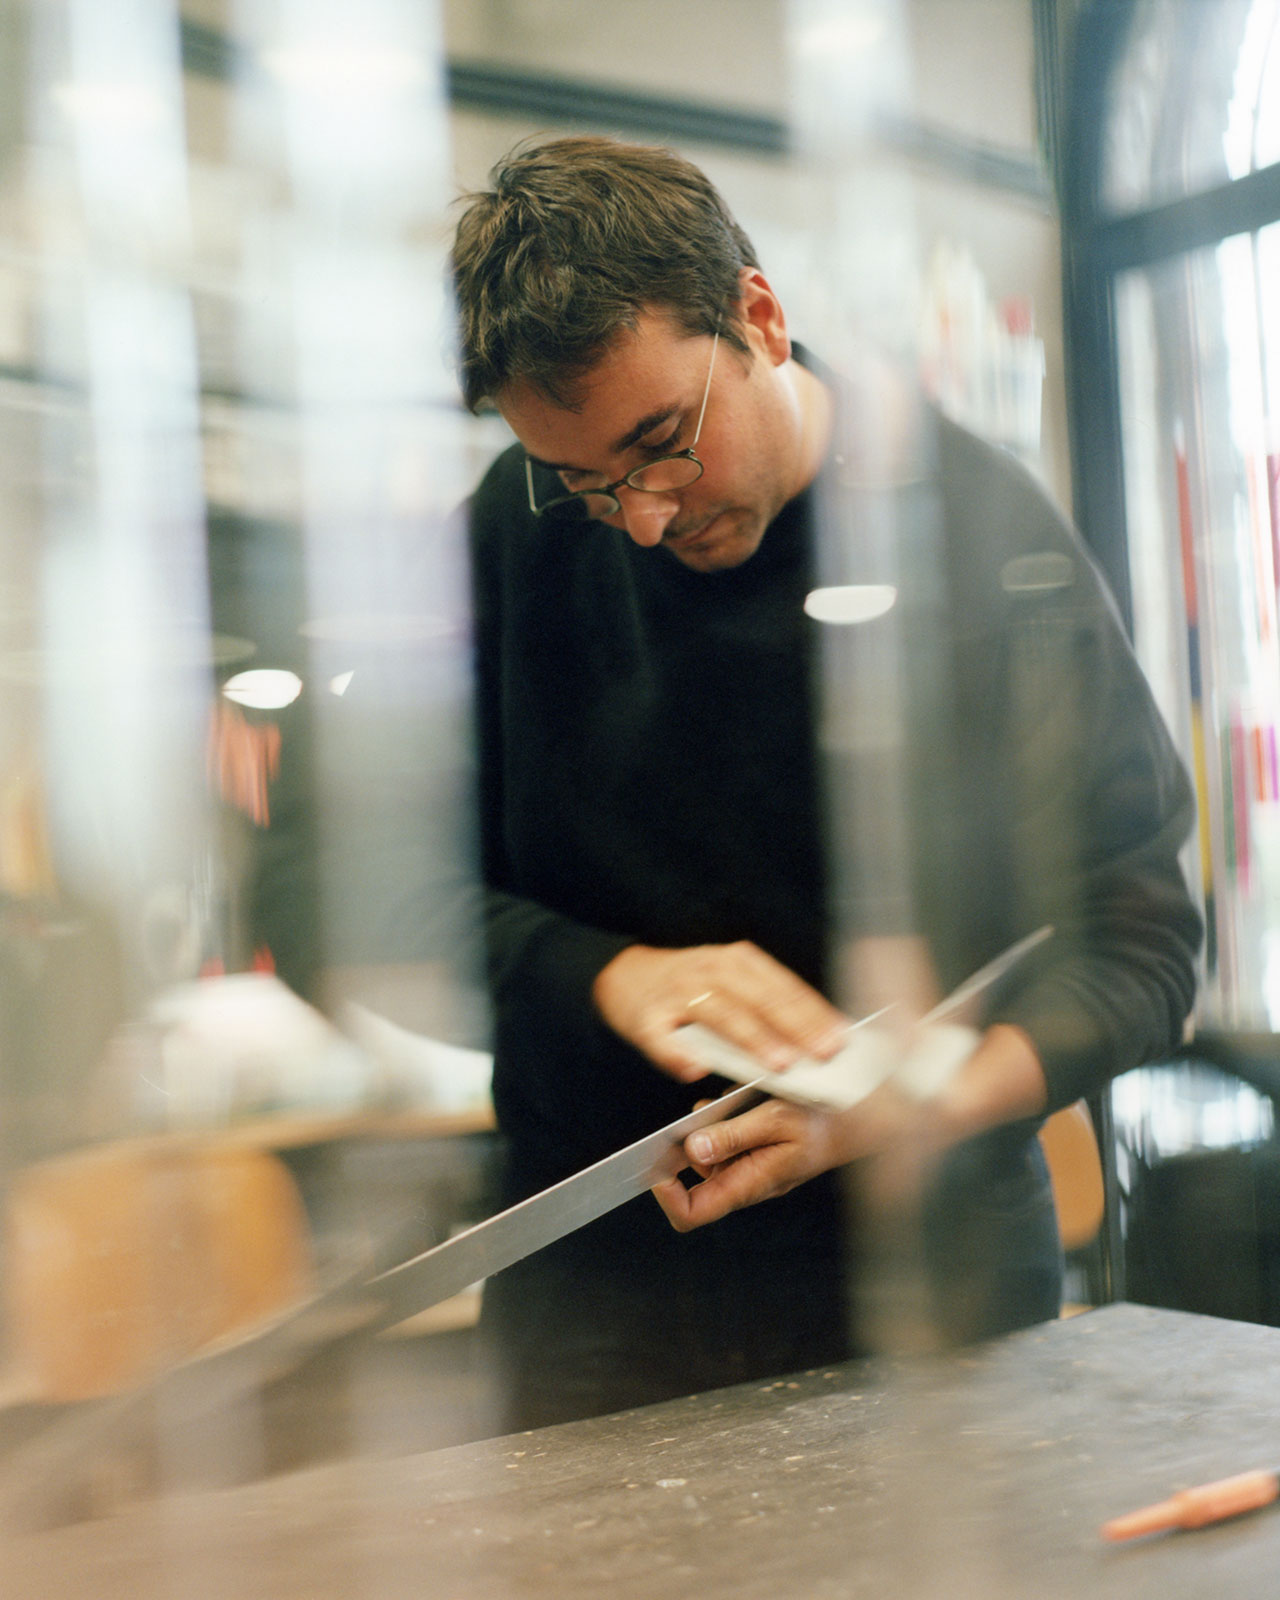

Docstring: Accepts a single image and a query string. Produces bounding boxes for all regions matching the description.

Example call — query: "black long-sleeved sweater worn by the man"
[470,403,1200,1227]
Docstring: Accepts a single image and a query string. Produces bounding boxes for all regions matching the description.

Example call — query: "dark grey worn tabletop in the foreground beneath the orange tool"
[0,1306,1280,1600]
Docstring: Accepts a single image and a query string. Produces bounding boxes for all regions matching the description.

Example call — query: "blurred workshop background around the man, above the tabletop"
[0,0,1280,1520]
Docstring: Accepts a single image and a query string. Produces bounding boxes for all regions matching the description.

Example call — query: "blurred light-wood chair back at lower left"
[5,1138,314,1403]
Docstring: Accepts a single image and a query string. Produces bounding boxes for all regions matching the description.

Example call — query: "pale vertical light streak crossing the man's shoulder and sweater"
[789,0,930,992]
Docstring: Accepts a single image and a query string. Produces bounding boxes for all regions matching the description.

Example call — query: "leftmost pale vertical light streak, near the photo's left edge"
[34,0,210,990]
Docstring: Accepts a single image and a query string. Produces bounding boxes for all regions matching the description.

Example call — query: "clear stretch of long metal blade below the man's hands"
[370,1083,763,1328]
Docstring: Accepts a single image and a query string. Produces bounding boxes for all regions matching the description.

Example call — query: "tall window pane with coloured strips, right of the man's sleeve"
[1117,224,1280,1027]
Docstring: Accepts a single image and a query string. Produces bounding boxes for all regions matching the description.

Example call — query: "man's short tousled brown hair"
[451,136,758,411]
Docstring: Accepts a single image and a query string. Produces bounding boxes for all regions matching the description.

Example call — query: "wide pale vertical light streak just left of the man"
[232,0,475,1034]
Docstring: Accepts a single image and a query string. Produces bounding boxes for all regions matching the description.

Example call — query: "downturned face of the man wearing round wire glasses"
[498,274,816,573]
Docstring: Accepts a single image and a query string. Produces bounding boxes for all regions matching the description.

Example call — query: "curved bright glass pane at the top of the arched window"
[1101,0,1280,214]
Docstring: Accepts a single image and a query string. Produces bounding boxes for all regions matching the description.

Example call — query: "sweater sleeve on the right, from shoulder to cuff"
[940,432,1202,1109]
